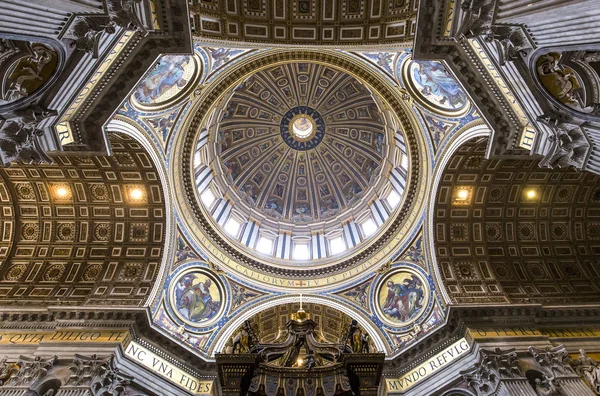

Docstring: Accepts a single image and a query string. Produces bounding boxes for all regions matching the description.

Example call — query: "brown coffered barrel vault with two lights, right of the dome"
[433,139,600,304]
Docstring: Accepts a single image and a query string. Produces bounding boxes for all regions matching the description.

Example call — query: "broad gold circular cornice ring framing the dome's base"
[169,49,431,289]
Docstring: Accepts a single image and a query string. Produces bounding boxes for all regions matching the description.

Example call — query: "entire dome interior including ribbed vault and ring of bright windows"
[193,61,409,267]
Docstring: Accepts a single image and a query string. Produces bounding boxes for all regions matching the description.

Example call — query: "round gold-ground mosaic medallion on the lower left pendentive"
[169,268,225,327]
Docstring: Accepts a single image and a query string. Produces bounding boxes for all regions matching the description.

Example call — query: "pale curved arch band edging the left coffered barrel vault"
[105,116,176,306]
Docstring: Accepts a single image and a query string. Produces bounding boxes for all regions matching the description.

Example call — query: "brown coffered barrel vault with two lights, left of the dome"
[0,133,166,306]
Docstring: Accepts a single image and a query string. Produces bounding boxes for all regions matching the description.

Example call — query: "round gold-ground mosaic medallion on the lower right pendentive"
[375,268,429,326]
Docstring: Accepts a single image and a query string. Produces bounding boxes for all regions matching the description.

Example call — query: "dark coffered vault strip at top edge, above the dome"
[190,0,418,47]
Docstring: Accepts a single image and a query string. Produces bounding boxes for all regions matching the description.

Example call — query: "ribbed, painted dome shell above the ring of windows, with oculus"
[215,63,388,225]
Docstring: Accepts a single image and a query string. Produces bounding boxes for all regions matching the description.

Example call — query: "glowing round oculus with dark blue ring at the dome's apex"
[280,106,325,151]
